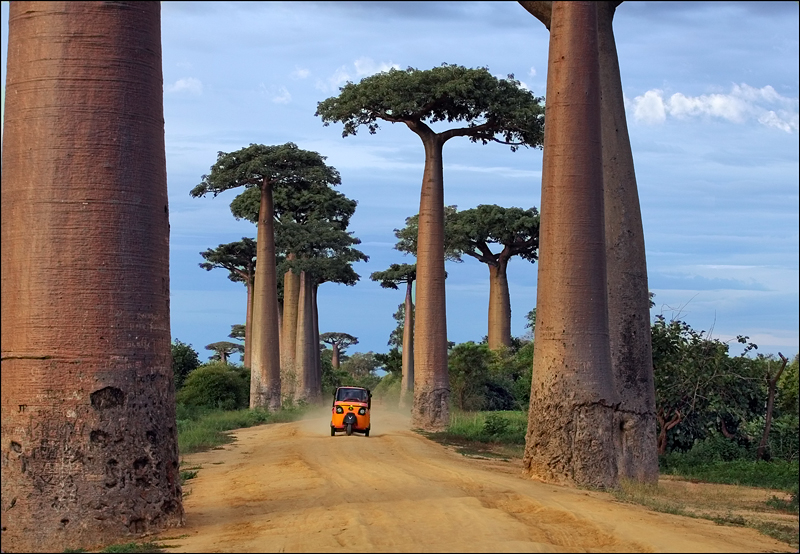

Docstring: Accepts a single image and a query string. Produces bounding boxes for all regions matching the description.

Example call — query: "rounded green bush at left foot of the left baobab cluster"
[177,362,250,410]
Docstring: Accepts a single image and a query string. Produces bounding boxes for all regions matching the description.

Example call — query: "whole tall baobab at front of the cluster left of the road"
[190,142,338,410]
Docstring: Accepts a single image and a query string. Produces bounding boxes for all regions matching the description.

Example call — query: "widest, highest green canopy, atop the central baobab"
[315,63,544,150]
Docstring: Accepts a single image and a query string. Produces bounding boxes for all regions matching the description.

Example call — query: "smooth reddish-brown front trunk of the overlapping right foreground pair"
[523,2,619,487]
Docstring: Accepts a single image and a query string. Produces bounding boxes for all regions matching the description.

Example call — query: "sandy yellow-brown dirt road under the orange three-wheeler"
[159,409,793,553]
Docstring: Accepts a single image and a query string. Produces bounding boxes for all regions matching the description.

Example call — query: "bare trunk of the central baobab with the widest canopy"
[411,134,450,431]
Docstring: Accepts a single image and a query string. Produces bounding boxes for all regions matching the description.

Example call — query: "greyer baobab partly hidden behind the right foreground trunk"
[520,1,658,483]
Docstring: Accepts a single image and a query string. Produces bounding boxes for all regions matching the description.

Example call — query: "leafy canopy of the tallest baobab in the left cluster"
[189,142,341,198]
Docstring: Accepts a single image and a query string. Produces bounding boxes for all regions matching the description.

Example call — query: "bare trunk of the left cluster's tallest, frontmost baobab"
[250,178,281,411]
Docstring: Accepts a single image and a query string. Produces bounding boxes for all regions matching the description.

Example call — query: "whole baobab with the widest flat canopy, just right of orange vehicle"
[316,64,544,431]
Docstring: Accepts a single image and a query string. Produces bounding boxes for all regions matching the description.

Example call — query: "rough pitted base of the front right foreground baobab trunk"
[523,399,619,489]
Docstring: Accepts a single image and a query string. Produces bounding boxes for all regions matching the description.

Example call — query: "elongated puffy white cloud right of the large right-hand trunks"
[632,83,798,133]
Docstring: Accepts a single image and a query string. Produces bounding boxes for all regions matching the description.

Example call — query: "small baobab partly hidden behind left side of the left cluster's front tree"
[199,237,256,367]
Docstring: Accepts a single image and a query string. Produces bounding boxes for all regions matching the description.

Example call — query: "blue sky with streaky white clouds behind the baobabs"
[0,2,800,360]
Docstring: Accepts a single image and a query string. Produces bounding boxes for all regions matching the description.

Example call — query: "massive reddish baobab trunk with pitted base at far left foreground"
[0,2,183,552]
